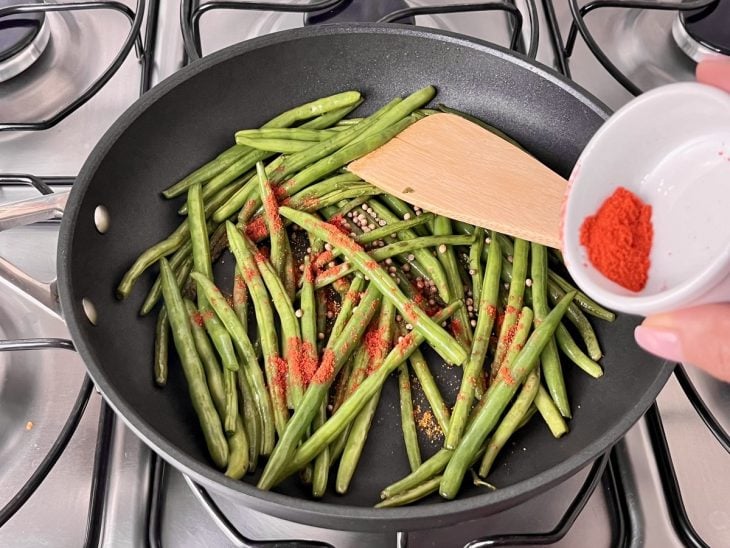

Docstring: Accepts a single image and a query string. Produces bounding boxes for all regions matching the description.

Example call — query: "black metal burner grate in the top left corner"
[0,0,151,132]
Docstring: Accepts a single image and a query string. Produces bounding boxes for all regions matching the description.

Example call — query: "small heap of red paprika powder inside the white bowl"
[580,187,654,291]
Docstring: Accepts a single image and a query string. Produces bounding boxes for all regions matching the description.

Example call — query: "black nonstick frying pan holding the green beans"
[1,24,671,531]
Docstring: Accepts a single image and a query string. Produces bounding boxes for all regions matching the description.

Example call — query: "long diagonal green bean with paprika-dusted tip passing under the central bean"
[277,302,463,480]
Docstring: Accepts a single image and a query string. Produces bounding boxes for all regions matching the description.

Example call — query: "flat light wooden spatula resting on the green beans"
[348,114,567,249]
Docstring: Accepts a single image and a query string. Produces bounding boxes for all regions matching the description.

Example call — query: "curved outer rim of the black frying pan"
[57,23,673,531]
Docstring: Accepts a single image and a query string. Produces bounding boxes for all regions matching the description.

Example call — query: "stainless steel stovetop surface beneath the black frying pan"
[0,0,730,548]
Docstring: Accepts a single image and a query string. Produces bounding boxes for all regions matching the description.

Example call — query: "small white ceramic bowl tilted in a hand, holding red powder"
[562,79,730,315]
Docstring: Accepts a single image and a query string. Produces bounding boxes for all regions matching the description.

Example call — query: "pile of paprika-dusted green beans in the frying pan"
[117,86,614,507]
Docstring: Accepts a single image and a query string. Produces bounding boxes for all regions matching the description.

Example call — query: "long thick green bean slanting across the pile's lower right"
[439,293,575,499]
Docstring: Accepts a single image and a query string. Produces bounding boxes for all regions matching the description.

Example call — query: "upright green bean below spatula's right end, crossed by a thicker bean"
[531,242,571,417]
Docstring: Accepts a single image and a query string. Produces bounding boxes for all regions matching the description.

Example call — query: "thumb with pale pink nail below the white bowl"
[634,304,730,381]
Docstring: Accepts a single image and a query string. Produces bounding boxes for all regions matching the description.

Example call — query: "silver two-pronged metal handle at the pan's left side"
[0,191,68,317]
